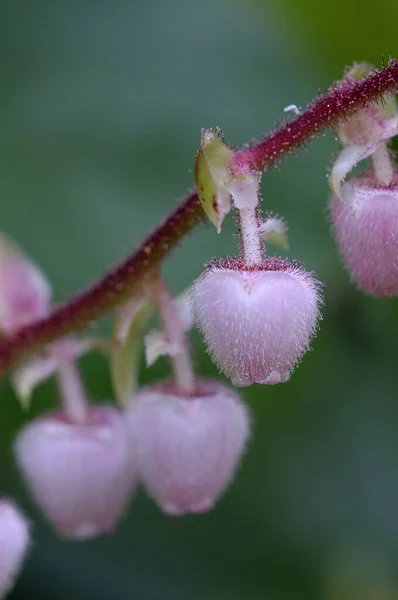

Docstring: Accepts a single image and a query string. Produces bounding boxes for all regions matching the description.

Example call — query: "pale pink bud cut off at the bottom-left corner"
[0,498,29,598]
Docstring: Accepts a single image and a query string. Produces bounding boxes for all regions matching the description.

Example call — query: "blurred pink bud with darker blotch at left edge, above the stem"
[0,234,51,335]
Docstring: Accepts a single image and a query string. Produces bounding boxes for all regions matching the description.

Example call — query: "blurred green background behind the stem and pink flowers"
[0,0,398,600]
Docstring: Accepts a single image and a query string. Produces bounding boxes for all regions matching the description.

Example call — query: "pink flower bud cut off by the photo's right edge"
[330,177,398,298]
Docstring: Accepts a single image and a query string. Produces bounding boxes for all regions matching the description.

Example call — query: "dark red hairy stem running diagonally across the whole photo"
[0,60,398,375]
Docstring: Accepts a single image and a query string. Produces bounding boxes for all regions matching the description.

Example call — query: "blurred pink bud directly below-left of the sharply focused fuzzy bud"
[127,381,249,516]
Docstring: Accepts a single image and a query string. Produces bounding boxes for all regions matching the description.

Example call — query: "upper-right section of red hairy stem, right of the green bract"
[231,59,398,173]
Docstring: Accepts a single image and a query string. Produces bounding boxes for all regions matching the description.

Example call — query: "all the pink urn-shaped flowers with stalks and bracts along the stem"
[0,65,398,598]
